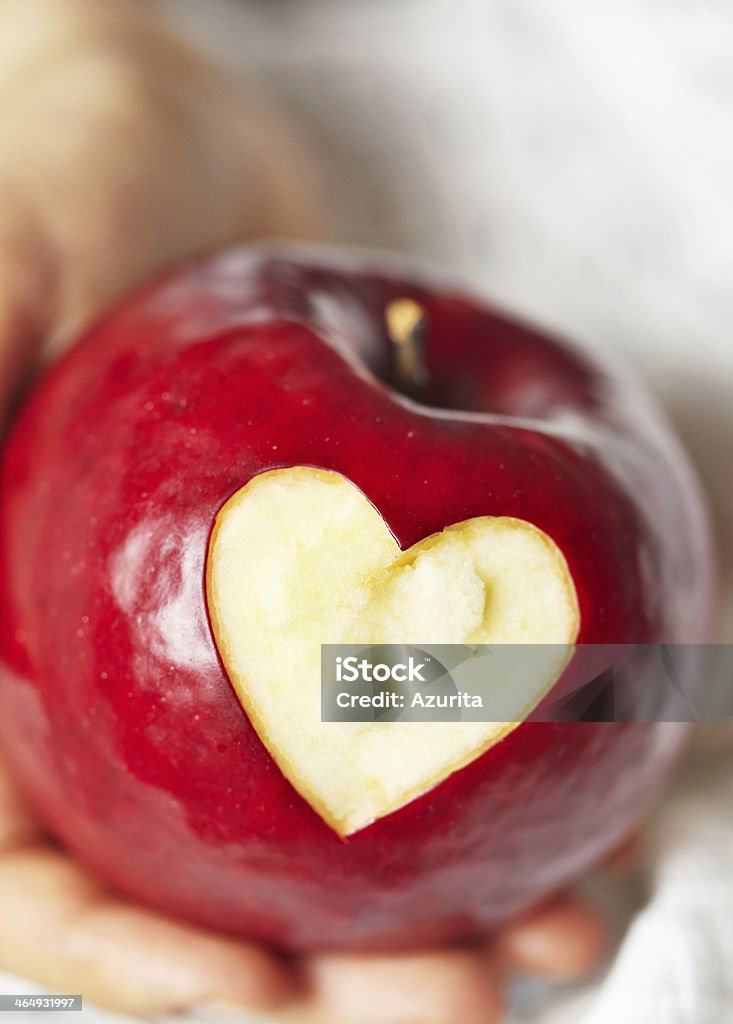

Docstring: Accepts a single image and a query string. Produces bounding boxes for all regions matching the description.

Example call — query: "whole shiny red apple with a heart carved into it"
[0,248,712,949]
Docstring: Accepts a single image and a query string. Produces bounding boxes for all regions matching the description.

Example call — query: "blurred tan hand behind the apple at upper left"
[0,0,322,409]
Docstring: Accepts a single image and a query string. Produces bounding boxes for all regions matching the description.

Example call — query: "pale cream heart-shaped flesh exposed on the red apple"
[207,466,579,836]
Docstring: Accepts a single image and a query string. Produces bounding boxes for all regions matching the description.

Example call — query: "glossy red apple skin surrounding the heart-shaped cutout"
[0,248,712,949]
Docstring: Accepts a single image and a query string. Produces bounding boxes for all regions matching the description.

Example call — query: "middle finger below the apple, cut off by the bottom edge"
[283,950,504,1024]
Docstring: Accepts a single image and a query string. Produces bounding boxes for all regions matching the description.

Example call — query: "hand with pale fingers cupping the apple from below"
[0,749,605,1024]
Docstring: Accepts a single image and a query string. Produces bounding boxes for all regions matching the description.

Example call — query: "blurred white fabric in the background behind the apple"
[0,0,733,1024]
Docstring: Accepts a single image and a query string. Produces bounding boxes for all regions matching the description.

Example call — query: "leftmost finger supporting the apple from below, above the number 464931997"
[0,846,291,1016]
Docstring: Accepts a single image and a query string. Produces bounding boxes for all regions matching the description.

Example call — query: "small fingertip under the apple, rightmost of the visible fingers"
[490,897,608,981]
